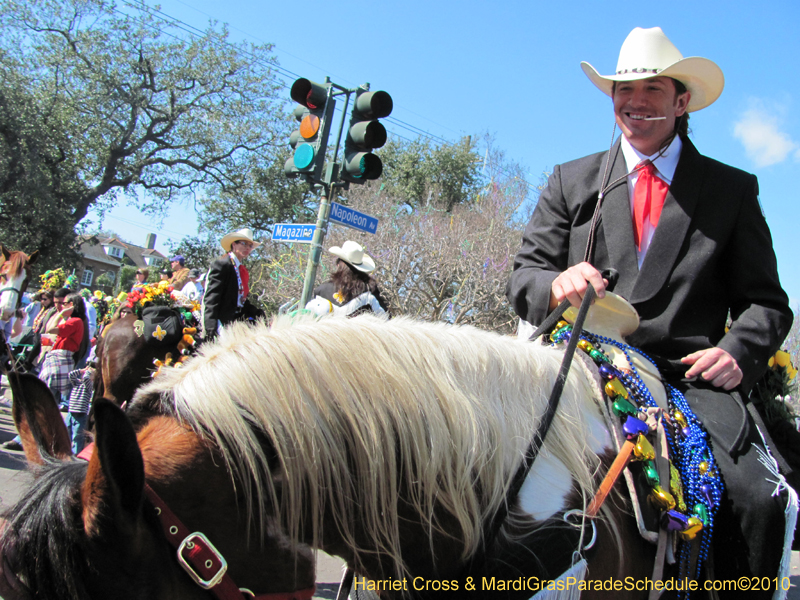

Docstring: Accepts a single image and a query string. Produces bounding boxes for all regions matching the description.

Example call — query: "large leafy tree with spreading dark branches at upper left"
[0,0,288,266]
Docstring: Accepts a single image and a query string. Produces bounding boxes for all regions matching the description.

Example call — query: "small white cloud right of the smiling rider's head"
[733,101,800,167]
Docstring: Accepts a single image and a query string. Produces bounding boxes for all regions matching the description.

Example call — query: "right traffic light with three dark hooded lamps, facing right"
[341,88,393,183]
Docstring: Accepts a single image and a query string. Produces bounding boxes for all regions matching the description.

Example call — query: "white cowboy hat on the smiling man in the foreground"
[581,27,725,112]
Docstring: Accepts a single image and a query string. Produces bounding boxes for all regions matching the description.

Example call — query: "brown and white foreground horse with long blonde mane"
[0,315,653,600]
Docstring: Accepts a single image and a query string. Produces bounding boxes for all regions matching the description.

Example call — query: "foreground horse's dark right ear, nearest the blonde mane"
[83,398,144,528]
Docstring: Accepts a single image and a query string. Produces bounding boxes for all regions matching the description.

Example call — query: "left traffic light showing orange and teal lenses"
[284,78,336,181]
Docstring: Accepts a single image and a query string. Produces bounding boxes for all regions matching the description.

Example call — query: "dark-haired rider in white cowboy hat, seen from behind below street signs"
[306,240,389,317]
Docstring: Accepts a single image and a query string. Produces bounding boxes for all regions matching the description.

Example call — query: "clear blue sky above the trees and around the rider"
[95,0,800,307]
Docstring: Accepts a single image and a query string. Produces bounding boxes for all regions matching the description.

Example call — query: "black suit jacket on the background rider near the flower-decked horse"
[203,254,264,340]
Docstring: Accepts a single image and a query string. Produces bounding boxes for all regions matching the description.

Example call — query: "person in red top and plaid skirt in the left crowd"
[39,294,89,401]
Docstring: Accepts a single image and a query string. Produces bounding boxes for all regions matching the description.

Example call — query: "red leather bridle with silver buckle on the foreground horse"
[78,444,316,600]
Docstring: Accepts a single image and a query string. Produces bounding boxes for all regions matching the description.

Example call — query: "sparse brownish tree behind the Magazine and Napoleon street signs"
[251,139,538,333]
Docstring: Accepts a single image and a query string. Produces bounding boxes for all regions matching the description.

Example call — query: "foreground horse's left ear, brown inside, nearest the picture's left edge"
[8,371,72,464]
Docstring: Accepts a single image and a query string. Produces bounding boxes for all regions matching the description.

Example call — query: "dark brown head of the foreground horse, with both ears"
[0,373,314,600]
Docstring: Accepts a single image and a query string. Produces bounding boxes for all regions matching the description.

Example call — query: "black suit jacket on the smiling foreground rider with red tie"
[507,138,793,390]
